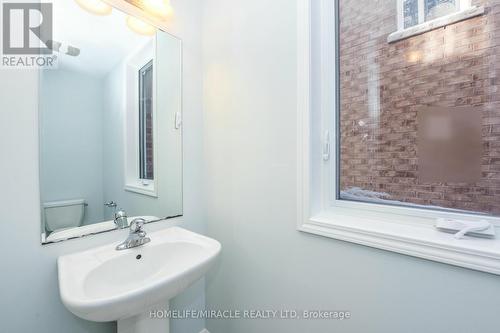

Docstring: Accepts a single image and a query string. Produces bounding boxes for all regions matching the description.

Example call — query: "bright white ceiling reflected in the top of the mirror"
[53,0,152,76]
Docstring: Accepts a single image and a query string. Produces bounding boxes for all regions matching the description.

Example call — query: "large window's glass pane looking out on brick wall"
[337,0,500,215]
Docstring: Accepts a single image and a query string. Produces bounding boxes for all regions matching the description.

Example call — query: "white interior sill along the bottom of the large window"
[298,208,500,275]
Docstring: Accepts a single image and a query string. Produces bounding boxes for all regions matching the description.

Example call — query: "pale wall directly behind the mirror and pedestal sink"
[0,0,204,333]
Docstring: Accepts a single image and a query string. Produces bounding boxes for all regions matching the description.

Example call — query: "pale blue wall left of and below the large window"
[203,0,500,333]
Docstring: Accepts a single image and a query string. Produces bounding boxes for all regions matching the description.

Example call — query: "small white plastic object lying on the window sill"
[436,218,495,239]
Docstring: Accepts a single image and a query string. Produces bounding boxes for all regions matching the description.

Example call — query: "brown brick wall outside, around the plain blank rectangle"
[340,0,500,214]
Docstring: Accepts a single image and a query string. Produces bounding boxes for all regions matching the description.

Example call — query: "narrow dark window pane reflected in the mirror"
[139,61,154,180]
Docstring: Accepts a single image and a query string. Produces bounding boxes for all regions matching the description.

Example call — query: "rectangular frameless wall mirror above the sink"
[39,1,182,243]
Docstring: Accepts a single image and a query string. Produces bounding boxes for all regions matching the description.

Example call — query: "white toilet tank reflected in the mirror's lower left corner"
[43,199,86,231]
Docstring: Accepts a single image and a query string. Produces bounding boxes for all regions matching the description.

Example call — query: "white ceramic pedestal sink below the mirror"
[57,227,221,333]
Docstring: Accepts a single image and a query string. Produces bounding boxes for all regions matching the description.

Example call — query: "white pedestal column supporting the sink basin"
[118,301,170,333]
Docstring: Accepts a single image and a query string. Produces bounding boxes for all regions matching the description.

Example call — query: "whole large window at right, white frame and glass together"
[298,0,500,274]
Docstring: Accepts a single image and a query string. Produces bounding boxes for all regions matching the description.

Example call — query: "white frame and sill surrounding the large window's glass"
[297,0,500,275]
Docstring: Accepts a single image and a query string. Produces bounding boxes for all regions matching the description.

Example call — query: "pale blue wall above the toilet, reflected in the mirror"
[40,70,104,224]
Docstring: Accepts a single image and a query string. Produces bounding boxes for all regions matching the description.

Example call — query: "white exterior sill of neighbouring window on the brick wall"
[387,6,484,43]
